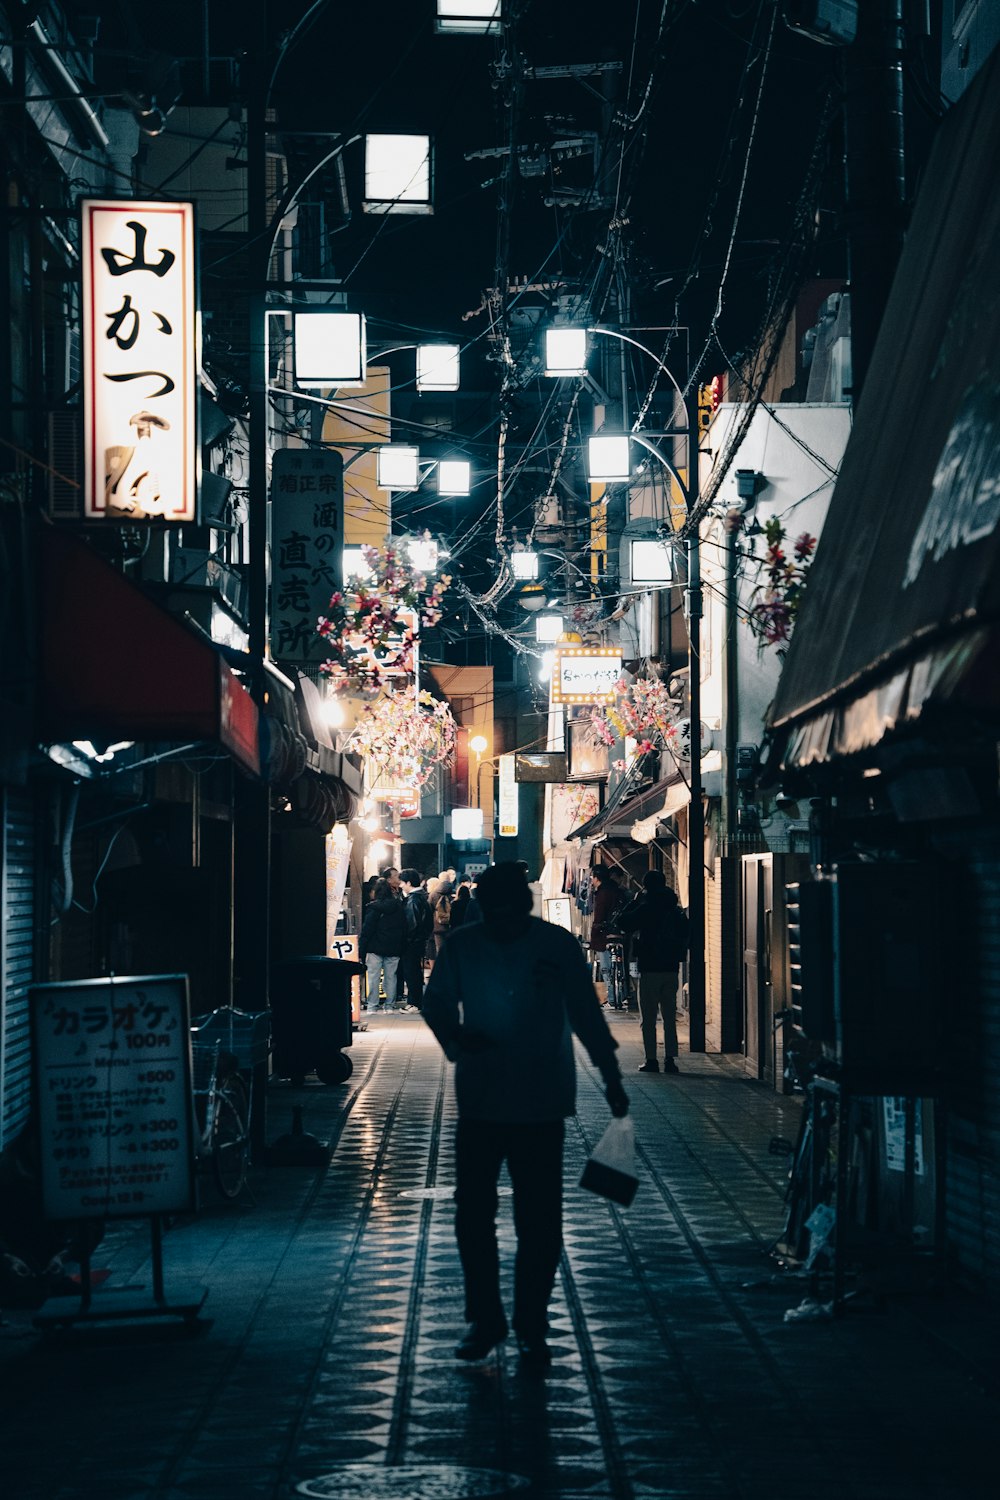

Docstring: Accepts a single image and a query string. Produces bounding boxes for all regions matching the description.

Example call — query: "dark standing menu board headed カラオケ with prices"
[31,974,193,1220]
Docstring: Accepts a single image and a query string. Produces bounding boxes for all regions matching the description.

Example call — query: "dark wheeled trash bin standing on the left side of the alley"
[271,954,364,1083]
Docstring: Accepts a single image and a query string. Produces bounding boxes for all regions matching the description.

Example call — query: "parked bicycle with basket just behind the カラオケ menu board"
[190,1005,267,1199]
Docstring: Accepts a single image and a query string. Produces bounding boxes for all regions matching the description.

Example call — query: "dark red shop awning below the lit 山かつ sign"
[37,528,261,774]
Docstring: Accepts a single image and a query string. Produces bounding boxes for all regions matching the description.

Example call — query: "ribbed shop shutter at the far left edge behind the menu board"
[0,789,34,1146]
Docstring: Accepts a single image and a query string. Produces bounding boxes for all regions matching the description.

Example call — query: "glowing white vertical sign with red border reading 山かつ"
[81,198,198,522]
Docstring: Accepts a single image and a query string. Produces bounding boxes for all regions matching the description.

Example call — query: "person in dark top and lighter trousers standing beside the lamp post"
[618,870,690,1073]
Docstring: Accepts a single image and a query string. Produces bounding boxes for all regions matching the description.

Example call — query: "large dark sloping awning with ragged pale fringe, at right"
[769,53,1000,768]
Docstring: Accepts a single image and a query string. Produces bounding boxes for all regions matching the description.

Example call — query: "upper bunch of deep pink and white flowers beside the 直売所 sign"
[316,531,451,695]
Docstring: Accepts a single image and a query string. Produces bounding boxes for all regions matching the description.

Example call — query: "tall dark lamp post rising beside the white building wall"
[687,387,705,1052]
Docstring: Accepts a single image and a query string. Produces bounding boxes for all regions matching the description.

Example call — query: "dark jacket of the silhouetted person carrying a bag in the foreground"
[424,917,621,1125]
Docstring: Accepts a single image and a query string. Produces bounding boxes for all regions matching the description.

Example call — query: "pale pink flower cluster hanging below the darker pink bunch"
[351,686,459,795]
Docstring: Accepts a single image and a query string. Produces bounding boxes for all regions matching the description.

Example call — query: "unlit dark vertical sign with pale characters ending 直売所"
[271,449,343,665]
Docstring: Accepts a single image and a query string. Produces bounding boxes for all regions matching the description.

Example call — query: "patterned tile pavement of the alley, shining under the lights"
[0,1016,999,1500]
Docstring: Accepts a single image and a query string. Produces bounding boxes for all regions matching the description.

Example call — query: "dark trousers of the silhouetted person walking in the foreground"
[454,1119,564,1338]
